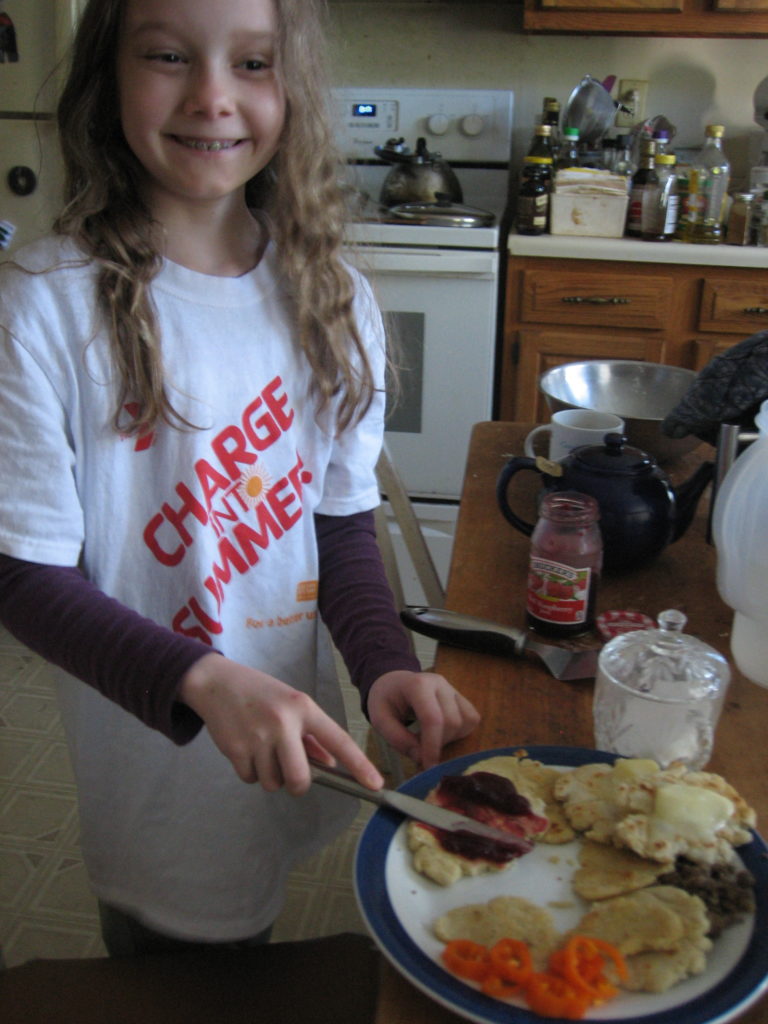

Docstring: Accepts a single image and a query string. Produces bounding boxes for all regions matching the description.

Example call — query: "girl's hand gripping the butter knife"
[178,652,384,796]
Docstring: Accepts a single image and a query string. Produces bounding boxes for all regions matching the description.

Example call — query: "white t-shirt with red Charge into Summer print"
[0,239,384,940]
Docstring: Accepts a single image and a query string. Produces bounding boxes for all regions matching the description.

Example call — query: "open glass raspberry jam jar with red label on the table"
[527,490,603,637]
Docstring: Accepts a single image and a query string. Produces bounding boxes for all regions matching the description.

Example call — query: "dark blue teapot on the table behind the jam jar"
[497,434,714,571]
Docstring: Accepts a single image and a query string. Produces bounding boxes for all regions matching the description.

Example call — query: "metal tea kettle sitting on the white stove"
[374,138,464,207]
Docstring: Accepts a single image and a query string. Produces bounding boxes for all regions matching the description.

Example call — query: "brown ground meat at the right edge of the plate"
[658,857,755,938]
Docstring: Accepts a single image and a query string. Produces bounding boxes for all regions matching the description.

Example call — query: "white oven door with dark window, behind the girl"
[361,246,499,501]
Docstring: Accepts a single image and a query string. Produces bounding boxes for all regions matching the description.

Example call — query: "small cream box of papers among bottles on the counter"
[550,167,629,239]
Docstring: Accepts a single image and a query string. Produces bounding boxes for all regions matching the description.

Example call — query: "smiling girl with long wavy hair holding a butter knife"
[0,0,477,952]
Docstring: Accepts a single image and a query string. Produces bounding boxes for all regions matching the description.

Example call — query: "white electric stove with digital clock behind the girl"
[335,87,513,503]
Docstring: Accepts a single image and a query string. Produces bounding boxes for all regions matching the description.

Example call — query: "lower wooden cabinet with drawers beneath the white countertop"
[498,256,768,422]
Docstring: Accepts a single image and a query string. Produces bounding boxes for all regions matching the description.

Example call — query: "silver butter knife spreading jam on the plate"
[309,758,532,853]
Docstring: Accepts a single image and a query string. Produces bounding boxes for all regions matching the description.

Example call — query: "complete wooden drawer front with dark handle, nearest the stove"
[520,269,674,331]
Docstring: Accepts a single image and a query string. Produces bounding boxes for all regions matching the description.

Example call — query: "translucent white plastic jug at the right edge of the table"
[712,399,768,686]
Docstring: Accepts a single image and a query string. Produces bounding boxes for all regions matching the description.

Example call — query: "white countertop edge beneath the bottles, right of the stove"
[508,232,768,269]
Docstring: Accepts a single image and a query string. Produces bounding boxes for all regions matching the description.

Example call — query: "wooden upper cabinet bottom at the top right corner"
[522,0,768,38]
